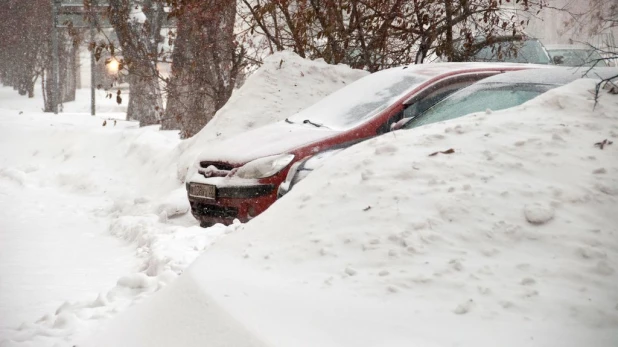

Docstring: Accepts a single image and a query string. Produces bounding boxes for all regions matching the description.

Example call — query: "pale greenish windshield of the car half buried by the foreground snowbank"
[403,83,557,129]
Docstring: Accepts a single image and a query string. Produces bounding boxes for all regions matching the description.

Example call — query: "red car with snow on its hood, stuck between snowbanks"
[186,63,538,226]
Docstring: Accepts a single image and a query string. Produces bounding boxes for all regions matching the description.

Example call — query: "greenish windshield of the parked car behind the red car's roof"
[473,40,550,64]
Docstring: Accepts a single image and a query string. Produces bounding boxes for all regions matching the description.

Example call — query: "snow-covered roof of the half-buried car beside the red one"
[476,67,618,85]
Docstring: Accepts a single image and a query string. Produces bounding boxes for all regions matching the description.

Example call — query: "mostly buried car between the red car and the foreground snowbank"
[278,67,618,198]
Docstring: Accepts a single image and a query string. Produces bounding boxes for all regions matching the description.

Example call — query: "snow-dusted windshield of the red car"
[287,69,432,130]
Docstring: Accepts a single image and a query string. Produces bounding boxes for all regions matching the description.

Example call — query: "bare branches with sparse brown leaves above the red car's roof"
[242,0,545,71]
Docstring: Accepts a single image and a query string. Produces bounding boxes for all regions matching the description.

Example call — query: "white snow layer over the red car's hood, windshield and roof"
[188,63,540,170]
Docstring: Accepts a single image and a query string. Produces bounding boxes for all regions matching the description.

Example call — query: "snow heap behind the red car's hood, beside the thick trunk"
[178,51,369,180]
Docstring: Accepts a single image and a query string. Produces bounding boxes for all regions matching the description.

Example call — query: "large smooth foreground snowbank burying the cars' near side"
[79,80,618,347]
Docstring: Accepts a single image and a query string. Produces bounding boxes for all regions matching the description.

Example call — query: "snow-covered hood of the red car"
[198,121,341,166]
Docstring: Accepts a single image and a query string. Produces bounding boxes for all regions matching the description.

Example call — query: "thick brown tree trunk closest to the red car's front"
[163,0,242,138]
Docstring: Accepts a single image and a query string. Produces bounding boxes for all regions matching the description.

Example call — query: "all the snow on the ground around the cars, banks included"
[0,52,618,347]
